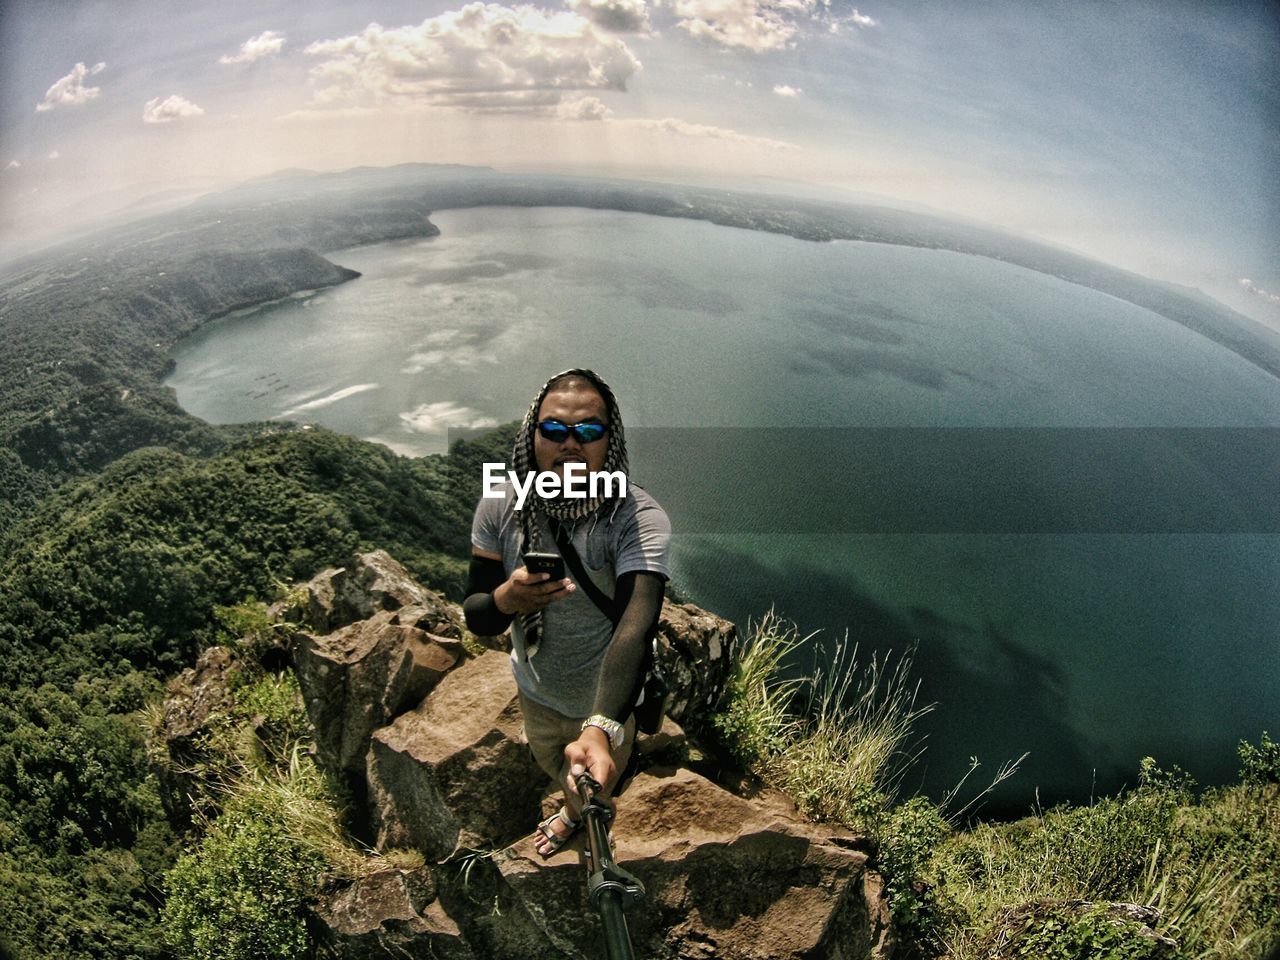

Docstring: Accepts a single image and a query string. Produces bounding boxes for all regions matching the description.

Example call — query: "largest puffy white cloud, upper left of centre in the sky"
[306,0,640,113]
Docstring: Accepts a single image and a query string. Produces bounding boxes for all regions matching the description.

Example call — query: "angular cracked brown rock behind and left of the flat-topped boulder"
[292,602,462,794]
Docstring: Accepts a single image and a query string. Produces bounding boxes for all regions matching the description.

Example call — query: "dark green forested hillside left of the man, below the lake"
[0,429,511,957]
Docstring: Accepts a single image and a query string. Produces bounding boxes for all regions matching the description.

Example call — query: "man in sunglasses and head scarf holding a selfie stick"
[463,369,671,859]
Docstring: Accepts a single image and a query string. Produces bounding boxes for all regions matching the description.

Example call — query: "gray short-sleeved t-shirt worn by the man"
[471,483,671,717]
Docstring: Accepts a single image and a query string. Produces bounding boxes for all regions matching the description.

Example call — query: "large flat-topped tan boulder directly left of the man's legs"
[367,652,550,860]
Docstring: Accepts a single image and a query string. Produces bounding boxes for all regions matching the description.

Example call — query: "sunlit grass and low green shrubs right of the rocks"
[714,611,1280,960]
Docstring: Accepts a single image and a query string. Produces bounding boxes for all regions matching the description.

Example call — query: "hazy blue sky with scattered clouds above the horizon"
[0,0,1280,329]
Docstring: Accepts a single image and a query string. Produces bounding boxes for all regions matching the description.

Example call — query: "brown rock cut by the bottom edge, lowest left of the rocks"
[312,867,475,960]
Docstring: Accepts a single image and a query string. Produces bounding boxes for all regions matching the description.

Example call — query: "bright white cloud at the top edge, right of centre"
[671,0,876,52]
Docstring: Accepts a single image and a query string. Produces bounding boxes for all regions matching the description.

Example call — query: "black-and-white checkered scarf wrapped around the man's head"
[511,367,627,653]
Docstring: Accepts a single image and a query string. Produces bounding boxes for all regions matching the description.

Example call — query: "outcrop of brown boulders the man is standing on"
[166,552,892,960]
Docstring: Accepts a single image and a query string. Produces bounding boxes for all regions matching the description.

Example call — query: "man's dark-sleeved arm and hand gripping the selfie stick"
[564,572,664,796]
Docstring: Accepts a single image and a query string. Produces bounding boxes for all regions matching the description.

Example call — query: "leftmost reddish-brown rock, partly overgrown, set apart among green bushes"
[152,646,241,829]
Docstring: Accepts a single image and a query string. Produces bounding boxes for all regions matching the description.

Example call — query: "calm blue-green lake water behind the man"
[169,209,1280,812]
